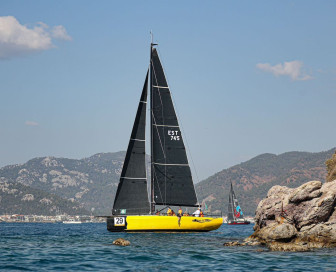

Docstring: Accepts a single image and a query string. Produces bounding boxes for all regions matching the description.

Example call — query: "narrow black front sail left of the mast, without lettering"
[112,71,150,215]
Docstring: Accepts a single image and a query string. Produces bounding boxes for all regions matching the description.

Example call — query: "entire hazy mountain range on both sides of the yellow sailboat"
[0,148,335,215]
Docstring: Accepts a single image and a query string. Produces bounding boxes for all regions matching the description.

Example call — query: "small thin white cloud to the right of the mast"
[256,60,313,80]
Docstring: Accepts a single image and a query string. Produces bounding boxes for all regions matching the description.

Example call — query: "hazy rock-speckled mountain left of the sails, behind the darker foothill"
[0,152,125,215]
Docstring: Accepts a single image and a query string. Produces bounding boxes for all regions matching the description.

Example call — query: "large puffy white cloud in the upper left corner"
[0,16,71,59]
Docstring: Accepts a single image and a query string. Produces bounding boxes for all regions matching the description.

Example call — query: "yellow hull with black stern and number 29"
[107,215,223,232]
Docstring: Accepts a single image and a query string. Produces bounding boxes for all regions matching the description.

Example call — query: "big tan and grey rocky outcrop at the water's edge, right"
[246,179,336,251]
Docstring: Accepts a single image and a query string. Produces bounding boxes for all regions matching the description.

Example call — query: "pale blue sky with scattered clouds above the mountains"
[0,0,336,182]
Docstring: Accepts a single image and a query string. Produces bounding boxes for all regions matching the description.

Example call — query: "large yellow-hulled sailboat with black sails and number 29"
[107,42,223,232]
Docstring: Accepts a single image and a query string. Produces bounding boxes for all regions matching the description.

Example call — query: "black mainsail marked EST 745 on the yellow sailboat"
[150,48,197,206]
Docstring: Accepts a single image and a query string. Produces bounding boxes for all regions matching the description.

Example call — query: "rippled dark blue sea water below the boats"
[0,223,336,271]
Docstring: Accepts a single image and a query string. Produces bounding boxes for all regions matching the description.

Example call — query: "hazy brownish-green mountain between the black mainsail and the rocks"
[196,148,335,215]
